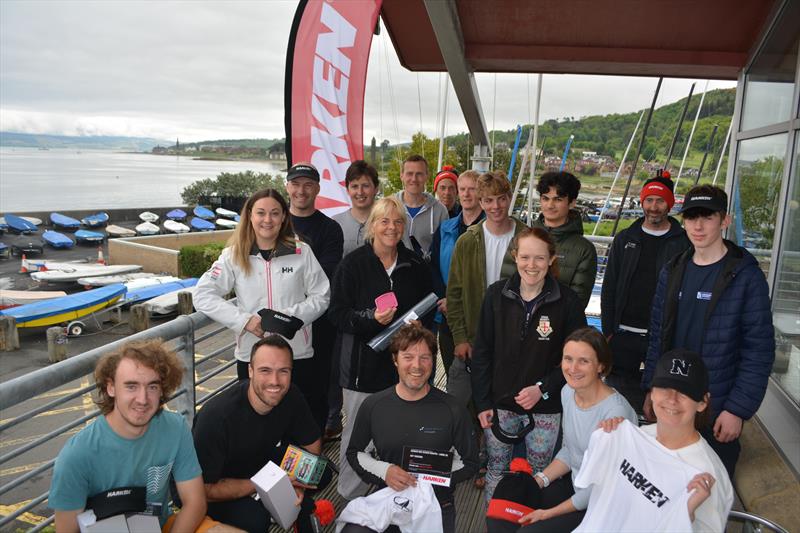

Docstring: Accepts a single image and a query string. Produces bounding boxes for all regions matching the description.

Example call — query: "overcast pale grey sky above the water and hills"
[0,0,735,143]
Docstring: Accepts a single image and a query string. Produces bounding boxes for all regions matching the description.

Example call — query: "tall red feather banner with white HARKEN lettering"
[285,0,381,215]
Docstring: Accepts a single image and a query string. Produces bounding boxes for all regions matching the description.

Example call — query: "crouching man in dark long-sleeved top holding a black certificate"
[343,323,478,533]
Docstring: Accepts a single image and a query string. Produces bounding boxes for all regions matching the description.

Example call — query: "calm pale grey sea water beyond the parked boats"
[0,147,286,213]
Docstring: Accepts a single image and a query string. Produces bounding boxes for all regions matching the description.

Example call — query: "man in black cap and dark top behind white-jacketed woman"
[286,163,344,428]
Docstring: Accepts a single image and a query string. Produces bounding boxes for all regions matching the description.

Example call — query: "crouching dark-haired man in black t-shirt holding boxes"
[194,335,322,533]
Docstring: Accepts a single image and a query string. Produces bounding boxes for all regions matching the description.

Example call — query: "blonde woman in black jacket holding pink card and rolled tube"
[328,197,433,499]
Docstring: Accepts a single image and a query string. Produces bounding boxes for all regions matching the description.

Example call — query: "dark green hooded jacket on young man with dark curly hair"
[533,210,597,309]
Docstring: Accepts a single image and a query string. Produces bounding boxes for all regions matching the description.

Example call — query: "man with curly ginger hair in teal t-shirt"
[49,339,211,533]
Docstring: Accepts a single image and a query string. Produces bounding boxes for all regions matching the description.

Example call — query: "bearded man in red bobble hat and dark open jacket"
[600,171,689,414]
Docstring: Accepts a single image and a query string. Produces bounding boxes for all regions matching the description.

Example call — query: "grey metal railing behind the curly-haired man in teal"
[0,313,236,533]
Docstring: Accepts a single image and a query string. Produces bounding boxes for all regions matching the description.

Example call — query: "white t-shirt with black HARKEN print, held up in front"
[575,420,701,532]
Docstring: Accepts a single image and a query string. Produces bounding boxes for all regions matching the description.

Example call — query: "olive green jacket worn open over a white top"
[447,217,526,344]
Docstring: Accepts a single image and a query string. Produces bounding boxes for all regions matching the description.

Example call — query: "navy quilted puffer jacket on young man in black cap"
[642,240,775,420]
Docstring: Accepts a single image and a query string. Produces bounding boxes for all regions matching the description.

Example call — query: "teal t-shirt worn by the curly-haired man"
[49,411,202,526]
